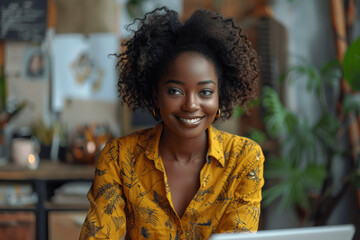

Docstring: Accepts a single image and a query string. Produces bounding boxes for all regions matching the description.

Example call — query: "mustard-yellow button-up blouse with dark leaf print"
[80,123,264,240]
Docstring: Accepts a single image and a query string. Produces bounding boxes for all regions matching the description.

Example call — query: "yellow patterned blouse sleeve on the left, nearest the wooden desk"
[80,143,126,240]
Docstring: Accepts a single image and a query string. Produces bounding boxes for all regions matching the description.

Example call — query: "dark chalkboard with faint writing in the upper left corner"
[0,0,47,42]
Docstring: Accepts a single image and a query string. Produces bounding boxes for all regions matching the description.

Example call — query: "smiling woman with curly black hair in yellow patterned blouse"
[80,8,264,239]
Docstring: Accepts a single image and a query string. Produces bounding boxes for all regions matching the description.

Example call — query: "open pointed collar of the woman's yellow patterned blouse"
[145,122,225,167]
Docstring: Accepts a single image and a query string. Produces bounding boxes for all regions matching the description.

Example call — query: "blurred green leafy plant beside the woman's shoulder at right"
[262,38,360,225]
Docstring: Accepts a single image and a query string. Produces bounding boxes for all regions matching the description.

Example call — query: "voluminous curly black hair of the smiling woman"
[117,7,259,119]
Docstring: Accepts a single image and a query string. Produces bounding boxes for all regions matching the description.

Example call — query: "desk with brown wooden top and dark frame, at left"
[0,160,95,240]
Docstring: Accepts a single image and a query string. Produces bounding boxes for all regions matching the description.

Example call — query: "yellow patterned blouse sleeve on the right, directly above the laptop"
[217,145,264,233]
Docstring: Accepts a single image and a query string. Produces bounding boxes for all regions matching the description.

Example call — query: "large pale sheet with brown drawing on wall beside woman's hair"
[52,33,118,111]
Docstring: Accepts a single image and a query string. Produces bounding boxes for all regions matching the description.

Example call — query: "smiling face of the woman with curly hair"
[157,52,219,138]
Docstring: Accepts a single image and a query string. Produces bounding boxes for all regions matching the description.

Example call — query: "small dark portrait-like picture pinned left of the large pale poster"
[22,47,49,80]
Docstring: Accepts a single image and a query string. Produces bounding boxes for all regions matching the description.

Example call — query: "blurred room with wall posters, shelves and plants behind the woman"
[0,0,360,240]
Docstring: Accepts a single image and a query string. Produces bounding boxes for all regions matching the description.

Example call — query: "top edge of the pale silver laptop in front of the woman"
[209,224,355,240]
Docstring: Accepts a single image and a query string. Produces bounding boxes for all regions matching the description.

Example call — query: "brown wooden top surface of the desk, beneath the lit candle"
[0,160,95,180]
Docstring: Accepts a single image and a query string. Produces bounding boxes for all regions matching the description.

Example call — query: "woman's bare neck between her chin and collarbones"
[159,126,208,163]
